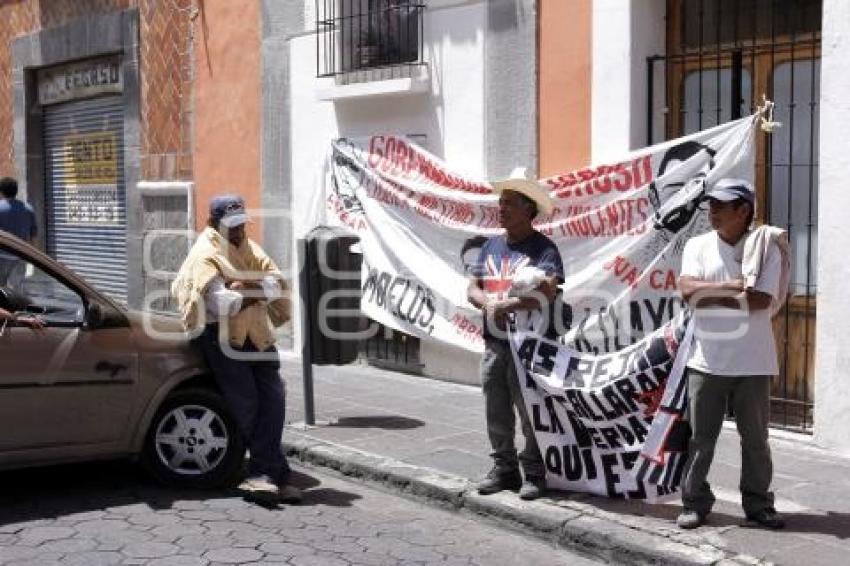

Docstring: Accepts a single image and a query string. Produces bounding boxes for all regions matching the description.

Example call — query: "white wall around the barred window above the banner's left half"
[290,0,486,382]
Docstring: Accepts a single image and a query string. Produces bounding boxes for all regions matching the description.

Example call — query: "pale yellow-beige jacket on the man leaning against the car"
[171,227,290,350]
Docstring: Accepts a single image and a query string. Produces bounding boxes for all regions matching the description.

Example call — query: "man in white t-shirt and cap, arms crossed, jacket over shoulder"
[676,179,784,529]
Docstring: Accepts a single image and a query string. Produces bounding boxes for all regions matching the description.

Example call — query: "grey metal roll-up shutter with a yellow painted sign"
[44,96,127,303]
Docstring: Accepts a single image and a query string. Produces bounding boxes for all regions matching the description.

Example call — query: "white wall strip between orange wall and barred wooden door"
[591,0,666,163]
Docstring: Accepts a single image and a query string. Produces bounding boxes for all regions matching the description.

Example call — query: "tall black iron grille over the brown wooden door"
[646,0,822,432]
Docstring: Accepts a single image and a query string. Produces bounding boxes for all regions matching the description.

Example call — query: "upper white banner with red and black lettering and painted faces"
[305,117,756,354]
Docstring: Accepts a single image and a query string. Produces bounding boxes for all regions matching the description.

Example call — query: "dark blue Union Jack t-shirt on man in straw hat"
[472,232,564,337]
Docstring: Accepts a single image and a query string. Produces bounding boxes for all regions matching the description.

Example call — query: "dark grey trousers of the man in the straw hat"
[481,338,545,480]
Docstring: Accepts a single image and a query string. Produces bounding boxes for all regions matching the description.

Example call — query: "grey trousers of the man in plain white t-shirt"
[682,368,773,515]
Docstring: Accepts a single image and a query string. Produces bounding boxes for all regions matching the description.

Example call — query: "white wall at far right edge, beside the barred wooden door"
[815,0,850,455]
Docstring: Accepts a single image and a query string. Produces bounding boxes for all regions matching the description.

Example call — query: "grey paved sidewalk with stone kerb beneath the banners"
[282,357,850,565]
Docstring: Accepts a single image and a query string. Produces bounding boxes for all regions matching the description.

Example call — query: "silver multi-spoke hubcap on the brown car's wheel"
[156,405,228,475]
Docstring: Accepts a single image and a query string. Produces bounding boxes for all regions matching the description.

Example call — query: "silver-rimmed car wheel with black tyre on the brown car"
[142,389,245,488]
